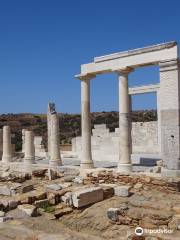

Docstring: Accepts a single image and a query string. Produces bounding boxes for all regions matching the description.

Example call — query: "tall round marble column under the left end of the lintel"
[79,75,95,169]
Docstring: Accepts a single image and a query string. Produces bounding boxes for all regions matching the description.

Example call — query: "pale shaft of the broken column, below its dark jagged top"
[49,113,62,166]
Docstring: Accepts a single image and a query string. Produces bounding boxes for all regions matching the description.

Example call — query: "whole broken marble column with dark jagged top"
[48,103,62,166]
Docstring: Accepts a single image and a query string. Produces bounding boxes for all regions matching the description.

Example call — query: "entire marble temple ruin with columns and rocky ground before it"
[0,42,180,240]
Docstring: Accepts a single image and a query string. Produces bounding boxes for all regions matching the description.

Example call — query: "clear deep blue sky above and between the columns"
[0,0,180,113]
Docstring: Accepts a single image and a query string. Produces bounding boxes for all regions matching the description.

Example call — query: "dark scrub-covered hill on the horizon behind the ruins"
[0,110,157,150]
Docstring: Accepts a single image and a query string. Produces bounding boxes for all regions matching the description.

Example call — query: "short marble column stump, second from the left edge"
[24,130,35,164]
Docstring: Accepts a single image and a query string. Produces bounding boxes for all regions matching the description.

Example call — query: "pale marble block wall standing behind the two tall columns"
[72,121,159,162]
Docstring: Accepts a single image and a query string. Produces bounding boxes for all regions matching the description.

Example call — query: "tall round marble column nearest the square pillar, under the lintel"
[118,69,132,172]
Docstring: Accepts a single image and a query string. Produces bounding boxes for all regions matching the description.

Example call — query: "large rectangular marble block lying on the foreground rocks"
[72,187,103,208]
